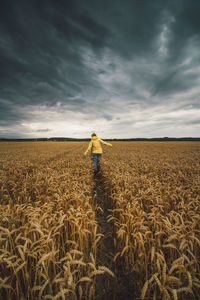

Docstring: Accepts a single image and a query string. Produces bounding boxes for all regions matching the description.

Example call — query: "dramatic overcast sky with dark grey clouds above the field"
[0,0,200,138]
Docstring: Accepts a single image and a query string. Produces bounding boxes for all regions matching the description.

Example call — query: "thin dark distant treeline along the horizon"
[0,137,200,142]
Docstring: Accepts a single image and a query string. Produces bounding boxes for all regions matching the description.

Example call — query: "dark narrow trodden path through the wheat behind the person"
[93,171,134,300]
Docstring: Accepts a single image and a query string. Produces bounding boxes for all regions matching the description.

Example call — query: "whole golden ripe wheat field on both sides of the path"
[0,142,200,300]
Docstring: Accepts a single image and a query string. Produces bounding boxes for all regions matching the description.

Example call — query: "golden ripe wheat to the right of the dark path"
[102,142,200,300]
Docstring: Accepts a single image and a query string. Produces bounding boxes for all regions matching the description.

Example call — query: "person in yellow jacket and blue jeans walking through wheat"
[84,133,112,174]
